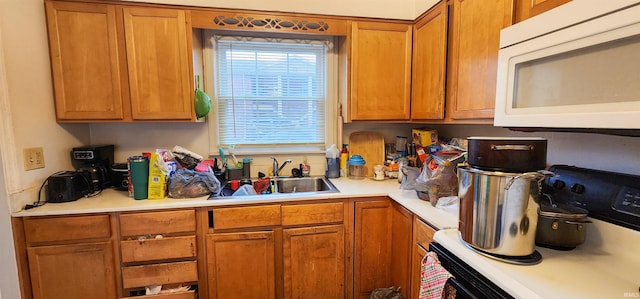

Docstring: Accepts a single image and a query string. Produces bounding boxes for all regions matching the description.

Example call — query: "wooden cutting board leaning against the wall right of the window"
[349,132,384,177]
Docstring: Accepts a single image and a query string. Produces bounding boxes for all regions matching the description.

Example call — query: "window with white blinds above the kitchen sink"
[205,32,337,152]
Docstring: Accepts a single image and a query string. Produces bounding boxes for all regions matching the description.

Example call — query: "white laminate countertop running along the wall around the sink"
[12,178,458,229]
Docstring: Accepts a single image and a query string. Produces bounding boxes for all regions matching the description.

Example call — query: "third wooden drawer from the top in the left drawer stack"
[122,261,198,289]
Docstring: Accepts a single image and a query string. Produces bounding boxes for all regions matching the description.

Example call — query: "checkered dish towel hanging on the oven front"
[418,251,453,299]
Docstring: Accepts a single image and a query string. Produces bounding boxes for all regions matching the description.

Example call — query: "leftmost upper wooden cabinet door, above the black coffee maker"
[45,1,126,121]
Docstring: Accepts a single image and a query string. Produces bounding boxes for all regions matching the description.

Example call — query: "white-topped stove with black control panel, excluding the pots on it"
[433,165,640,298]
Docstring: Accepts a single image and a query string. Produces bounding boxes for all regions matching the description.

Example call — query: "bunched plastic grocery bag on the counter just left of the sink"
[169,168,222,198]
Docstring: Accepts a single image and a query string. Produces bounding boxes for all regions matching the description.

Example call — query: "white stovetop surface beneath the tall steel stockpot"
[434,225,640,299]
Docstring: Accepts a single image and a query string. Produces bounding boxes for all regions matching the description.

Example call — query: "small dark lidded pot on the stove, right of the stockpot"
[536,201,591,250]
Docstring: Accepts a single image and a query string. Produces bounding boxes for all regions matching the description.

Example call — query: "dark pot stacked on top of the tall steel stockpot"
[467,137,547,173]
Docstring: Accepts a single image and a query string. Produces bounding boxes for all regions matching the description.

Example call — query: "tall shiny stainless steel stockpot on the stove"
[458,166,544,256]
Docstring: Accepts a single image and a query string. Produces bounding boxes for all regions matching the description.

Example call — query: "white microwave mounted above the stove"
[494,0,640,129]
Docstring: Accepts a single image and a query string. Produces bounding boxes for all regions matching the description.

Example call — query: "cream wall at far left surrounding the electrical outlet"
[0,0,89,211]
